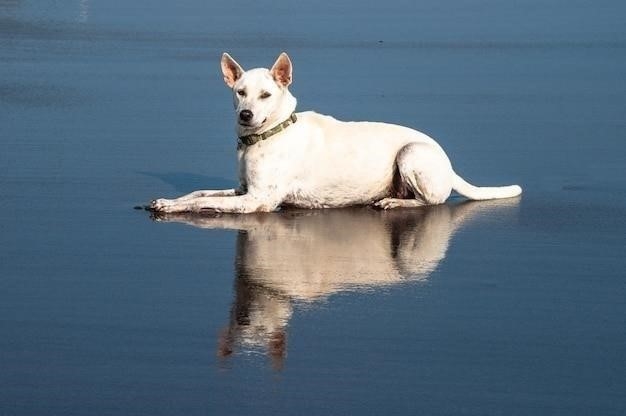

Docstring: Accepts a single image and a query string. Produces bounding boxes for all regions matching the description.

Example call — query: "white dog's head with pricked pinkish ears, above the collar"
[221,52,295,132]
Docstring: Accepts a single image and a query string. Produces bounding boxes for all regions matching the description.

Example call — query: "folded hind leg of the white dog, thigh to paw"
[375,143,454,209]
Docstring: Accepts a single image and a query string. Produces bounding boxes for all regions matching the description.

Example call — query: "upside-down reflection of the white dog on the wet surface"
[157,201,514,367]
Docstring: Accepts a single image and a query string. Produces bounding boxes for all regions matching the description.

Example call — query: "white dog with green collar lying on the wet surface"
[150,53,522,213]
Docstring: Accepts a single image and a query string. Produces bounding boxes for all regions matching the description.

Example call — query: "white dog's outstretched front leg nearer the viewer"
[150,193,282,214]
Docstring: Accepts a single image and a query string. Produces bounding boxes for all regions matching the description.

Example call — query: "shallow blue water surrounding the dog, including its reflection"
[0,0,626,415]
